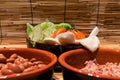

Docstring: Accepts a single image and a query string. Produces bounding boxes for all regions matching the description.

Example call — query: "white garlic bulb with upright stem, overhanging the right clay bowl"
[75,27,100,52]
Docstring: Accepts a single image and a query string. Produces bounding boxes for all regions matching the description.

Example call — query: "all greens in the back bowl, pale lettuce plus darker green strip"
[27,21,72,42]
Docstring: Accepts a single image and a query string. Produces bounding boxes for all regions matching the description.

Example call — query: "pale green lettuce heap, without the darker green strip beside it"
[27,22,55,42]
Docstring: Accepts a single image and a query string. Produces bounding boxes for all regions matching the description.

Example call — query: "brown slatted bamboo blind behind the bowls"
[0,0,120,44]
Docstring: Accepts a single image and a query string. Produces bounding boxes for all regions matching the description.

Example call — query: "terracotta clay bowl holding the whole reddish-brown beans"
[0,48,57,80]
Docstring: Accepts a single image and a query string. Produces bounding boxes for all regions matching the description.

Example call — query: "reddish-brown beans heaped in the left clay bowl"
[0,53,46,76]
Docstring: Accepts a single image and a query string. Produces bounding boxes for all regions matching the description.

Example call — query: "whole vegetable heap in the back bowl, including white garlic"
[27,21,100,52]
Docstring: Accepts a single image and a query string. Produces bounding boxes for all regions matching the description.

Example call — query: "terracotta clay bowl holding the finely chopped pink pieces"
[58,47,120,80]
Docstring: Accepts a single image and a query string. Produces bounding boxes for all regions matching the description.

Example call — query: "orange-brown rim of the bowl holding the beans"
[0,48,57,80]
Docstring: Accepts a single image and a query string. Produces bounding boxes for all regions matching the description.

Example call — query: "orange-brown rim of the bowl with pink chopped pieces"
[58,47,120,80]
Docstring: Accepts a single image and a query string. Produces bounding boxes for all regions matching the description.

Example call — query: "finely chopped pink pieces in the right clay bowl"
[80,59,120,77]
